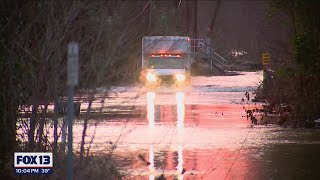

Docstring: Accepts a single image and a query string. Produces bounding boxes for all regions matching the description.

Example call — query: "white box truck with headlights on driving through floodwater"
[141,36,192,87]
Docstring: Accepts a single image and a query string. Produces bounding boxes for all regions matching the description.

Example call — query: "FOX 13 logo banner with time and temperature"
[14,152,53,174]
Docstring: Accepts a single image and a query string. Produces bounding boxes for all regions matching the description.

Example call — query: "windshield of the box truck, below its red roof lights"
[148,57,184,69]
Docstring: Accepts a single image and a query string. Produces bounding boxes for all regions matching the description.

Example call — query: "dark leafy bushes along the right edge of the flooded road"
[257,0,320,127]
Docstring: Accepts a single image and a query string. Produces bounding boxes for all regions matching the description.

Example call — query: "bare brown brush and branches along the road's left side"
[0,0,149,179]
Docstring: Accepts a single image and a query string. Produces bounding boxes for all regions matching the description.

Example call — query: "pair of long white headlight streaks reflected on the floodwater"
[146,92,185,180]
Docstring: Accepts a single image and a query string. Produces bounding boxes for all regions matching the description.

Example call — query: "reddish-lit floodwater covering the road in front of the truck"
[20,72,320,180]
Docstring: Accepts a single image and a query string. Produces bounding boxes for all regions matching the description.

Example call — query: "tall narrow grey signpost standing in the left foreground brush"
[67,42,79,180]
